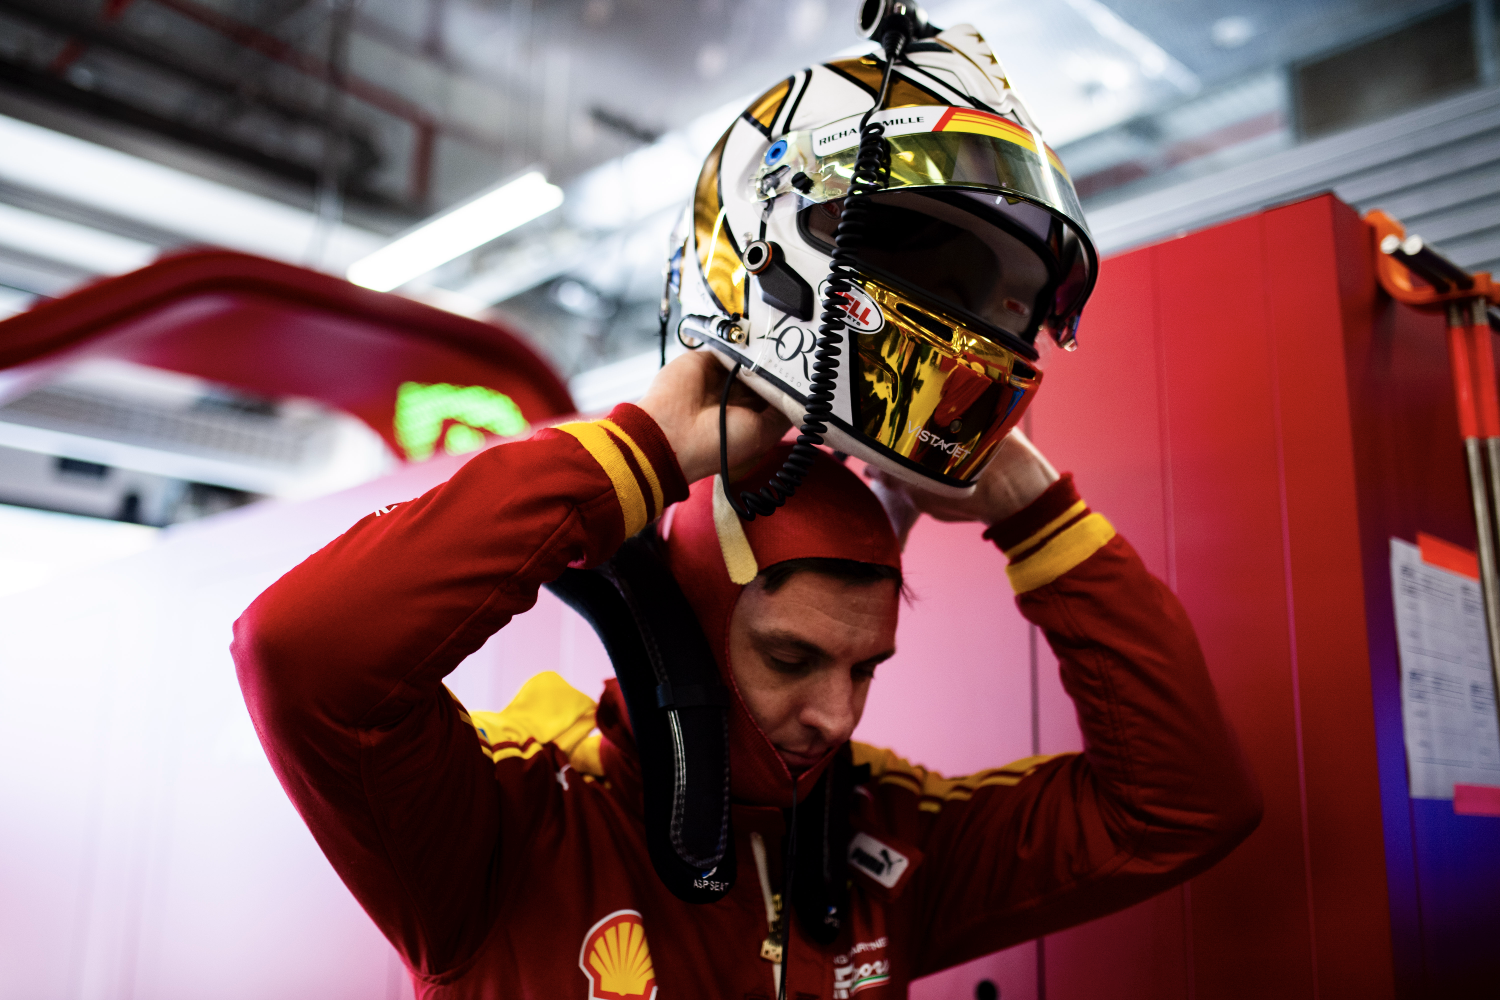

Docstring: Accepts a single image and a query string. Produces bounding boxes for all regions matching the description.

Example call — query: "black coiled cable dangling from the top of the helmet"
[719,30,911,520]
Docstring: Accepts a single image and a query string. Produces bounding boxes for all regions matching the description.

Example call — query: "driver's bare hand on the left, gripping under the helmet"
[636,349,792,483]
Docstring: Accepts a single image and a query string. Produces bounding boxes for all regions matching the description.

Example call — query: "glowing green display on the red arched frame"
[395,382,528,462]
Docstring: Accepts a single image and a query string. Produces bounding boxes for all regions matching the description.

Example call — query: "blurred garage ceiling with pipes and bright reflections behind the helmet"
[0,0,1490,372]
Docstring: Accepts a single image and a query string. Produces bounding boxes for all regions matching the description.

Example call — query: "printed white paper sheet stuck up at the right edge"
[1391,538,1500,799]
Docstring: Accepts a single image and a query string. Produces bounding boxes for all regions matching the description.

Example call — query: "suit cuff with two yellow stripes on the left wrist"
[555,403,687,538]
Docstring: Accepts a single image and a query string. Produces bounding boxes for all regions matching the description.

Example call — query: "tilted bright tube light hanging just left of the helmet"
[350,171,563,292]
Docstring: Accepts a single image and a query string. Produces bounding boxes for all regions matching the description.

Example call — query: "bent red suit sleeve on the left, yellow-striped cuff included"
[233,406,687,975]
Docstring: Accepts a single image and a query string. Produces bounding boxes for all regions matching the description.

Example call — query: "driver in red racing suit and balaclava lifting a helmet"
[234,351,1260,1000]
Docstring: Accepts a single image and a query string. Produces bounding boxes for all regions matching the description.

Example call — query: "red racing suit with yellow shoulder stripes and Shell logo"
[234,406,1260,1000]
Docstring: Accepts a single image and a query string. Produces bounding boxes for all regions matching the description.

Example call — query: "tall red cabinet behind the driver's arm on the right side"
[1032,195,1500,1000]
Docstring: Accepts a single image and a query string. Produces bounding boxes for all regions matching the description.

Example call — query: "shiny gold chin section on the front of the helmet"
[849,280,1041,486]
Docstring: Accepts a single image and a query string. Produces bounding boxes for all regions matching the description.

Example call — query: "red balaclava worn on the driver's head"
[663,444,902,808]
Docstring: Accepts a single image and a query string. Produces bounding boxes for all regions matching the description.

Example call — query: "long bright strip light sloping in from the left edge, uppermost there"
[0,115,380,270]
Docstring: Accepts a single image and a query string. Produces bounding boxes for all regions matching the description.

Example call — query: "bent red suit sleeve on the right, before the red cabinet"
[875,446,1262,975]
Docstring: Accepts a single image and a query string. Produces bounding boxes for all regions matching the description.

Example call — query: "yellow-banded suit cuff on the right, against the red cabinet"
[984,472,1115,594]
